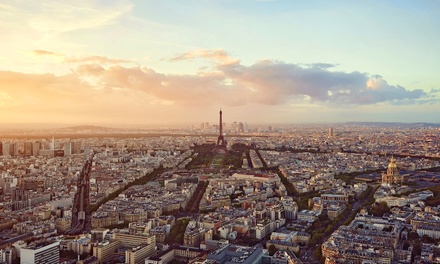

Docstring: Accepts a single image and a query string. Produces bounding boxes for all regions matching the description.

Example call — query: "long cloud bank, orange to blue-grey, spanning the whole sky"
[0,50,438,124]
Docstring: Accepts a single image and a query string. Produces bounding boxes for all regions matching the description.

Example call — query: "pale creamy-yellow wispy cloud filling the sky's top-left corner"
[0,0,132,67]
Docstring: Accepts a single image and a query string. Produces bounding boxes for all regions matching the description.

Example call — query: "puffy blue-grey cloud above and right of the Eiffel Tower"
[220,60,426,105]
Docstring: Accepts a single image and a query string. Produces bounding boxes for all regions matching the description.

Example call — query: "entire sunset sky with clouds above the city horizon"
[0,0,440,125]
